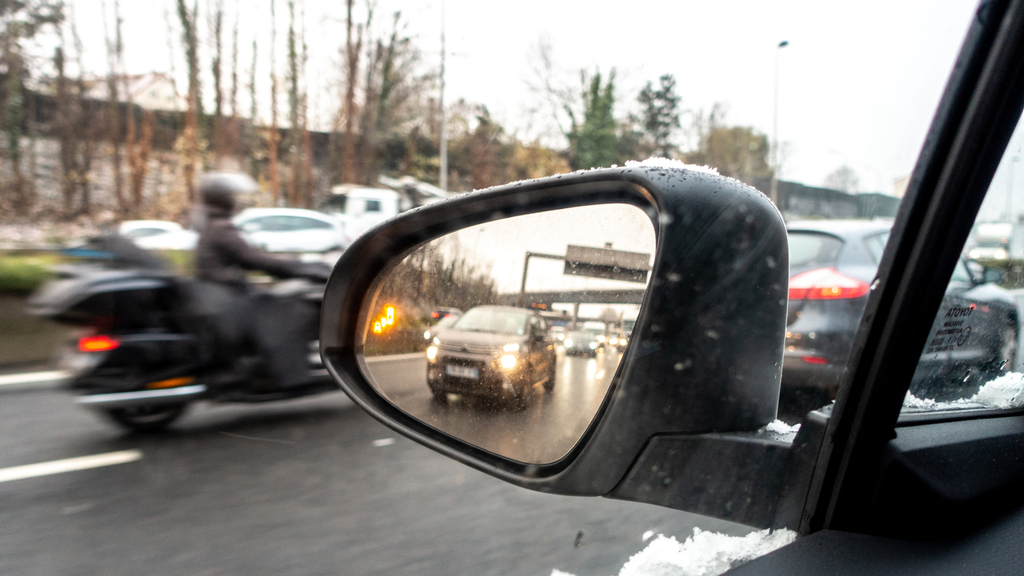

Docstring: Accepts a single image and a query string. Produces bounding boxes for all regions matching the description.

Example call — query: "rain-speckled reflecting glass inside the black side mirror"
[362,204,655,464]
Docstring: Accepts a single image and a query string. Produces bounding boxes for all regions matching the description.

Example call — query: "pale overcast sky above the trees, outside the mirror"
[58,0,976,192]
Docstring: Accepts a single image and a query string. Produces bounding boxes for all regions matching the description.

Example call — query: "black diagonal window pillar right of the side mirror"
[800,0,1024,533]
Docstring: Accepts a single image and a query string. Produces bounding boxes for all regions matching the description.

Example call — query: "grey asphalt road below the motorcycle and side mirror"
[0,368,748,576]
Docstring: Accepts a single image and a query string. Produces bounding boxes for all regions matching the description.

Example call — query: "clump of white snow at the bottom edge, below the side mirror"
[551,528,797,576]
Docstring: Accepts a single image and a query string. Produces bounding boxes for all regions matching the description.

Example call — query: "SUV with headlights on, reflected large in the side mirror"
[427,305,556,407]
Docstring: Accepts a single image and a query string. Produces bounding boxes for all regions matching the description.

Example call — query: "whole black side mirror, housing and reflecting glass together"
[319,164,790,524]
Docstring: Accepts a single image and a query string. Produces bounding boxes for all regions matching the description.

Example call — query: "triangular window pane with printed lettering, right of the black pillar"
[903,108,1024,414]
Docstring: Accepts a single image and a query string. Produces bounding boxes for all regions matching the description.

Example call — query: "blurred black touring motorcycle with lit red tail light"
[28,236,338,431]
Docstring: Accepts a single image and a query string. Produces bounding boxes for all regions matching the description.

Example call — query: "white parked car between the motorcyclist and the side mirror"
[231,208,348,252]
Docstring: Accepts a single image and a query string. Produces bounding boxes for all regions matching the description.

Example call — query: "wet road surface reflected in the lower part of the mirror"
[368,348,622,464]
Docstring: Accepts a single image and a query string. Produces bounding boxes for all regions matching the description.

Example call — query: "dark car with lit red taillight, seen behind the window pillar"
[780,220,1019,414]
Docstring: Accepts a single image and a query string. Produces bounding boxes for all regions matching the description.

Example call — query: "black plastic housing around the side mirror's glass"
[321,165,790,498]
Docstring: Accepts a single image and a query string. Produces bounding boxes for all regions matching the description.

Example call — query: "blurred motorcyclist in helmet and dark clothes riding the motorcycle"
[196,173,326,387]
